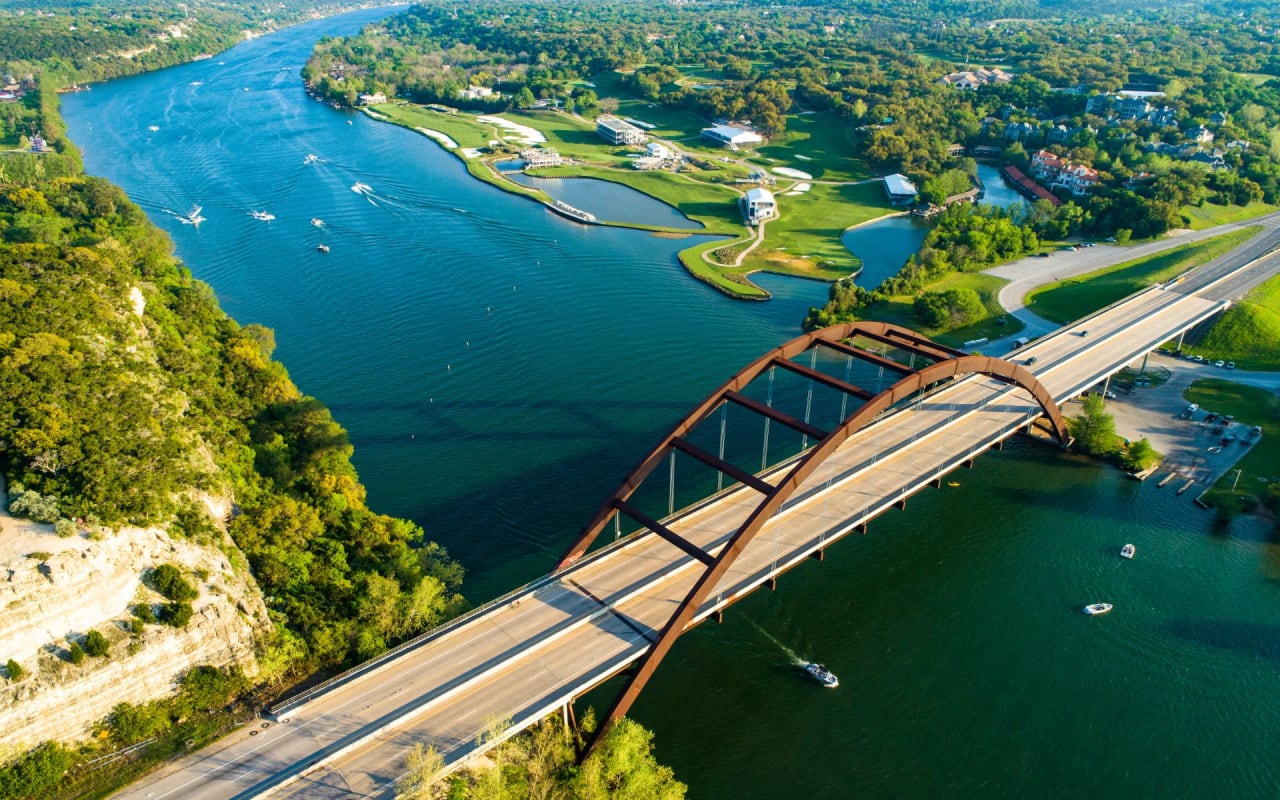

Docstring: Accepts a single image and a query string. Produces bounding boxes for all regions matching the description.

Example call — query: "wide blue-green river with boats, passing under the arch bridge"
[63,10,1280,799]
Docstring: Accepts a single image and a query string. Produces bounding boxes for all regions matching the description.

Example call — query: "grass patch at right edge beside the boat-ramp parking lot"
[1183,378,1280,495]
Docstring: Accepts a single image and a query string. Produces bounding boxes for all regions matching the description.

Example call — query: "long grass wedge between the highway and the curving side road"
[1025,228,1260,324]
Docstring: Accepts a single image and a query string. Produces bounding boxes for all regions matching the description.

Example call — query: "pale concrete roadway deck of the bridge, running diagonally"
[118,227,1280,800]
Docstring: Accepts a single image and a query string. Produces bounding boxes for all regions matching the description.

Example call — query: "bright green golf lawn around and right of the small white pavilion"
[748,182,890,279]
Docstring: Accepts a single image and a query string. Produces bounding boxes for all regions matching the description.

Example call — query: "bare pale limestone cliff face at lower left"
[0,489,268,756]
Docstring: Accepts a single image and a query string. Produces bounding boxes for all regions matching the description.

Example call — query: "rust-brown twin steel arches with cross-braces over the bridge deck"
[557,321,1070,751]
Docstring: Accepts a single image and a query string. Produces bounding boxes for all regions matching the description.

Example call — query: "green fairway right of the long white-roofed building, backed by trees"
[753,111,873,180]
